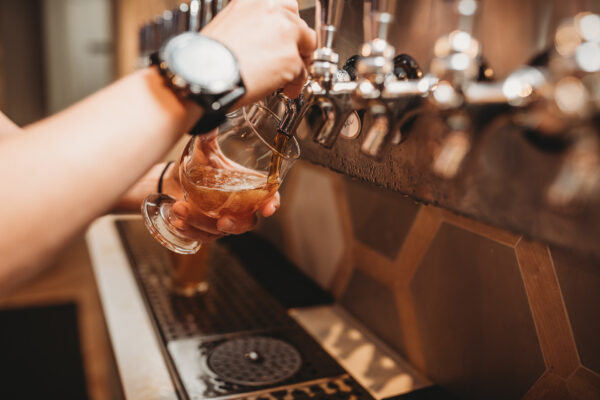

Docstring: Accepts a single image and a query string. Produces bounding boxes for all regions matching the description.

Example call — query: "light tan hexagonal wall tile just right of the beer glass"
[282,164,346,288]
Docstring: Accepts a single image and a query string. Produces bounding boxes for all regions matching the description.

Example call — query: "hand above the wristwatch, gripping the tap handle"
[201,0,316,105]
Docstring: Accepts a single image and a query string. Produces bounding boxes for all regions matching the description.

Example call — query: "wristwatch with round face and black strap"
[150,32,246,135]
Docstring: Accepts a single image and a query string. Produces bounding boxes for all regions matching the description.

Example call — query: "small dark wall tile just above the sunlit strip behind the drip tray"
[341,268,406,354]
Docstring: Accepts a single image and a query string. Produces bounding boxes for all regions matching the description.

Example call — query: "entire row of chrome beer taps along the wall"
[140,0,600,206]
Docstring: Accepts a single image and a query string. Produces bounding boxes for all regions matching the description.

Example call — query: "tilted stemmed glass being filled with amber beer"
[142,102,300,254]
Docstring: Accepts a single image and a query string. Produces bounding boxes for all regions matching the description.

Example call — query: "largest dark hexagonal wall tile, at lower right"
[411,223,545,400]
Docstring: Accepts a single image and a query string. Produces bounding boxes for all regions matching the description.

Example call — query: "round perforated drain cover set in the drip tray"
[208,336,302,386]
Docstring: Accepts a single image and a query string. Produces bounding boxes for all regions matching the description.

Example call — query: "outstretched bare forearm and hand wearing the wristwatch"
[0,0,314,293]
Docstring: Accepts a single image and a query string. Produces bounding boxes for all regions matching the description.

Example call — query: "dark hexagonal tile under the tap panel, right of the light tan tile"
[346,179,419,260]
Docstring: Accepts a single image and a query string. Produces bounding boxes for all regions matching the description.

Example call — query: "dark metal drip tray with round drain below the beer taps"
[116,220,371,400]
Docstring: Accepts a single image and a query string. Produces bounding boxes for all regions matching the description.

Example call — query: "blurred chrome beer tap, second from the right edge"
[430,0,507,179]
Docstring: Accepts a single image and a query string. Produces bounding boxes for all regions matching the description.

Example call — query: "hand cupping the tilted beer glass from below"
[163,163,280,242]
